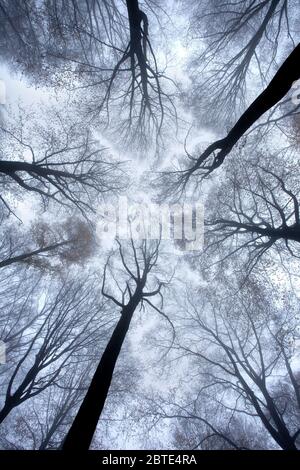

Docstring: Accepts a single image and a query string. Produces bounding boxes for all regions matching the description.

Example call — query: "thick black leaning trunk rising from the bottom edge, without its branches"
[62,293,142,451]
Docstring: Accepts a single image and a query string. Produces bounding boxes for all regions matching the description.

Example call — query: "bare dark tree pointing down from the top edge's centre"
[77,0,176,146]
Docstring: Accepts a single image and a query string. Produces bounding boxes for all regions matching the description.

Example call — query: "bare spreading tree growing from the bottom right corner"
[168,284,300,449]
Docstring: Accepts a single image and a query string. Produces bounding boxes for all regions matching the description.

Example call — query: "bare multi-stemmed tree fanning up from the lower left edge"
[0,281,107,422]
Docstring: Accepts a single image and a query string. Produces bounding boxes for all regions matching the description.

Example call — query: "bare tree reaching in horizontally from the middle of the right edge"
[205,155,300,274]
